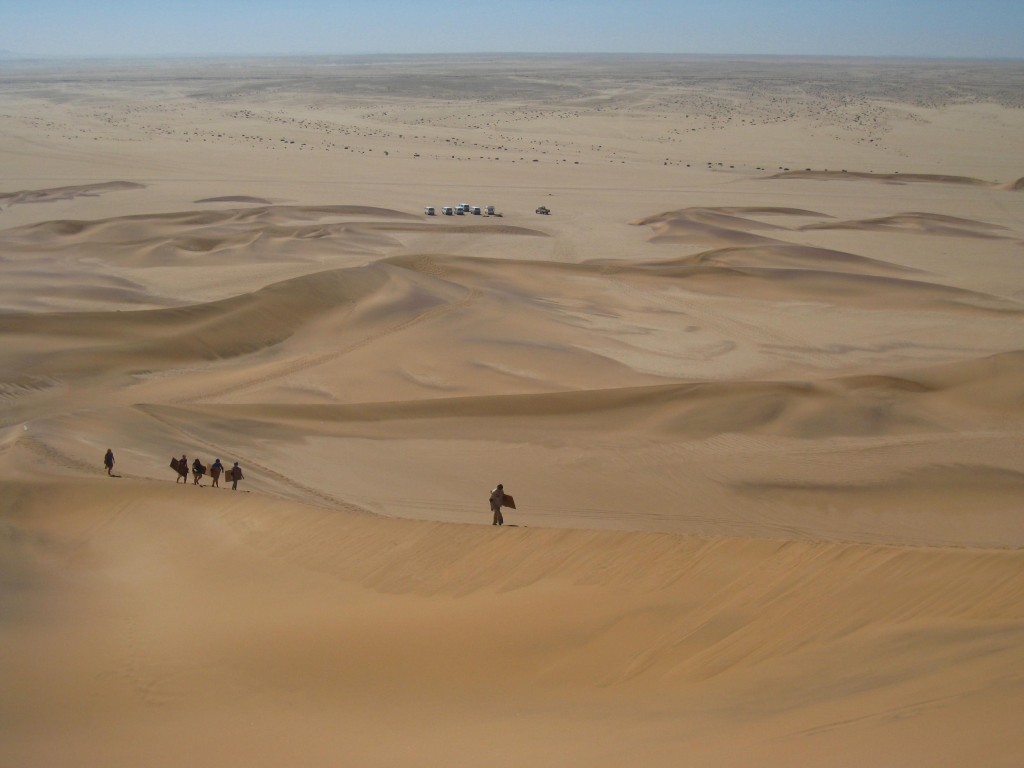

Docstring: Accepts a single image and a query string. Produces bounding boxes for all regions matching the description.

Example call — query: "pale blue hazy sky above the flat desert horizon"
[0,0,1024,58]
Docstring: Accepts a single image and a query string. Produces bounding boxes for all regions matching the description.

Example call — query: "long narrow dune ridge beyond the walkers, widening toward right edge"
[138,351,1024,439]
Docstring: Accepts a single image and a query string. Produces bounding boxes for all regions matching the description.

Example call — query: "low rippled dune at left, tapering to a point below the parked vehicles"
[0,206,545,311]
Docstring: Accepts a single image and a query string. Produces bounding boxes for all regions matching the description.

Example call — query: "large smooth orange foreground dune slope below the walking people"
[4,481,1022,766]
